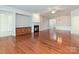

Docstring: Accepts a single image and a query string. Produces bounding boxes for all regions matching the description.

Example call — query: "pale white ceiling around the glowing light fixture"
[7,5,79,15]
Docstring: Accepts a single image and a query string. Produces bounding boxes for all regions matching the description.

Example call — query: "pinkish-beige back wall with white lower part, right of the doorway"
[55,15,71,31]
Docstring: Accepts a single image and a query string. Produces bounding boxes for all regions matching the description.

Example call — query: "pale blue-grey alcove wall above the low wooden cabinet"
[16,14,32,27]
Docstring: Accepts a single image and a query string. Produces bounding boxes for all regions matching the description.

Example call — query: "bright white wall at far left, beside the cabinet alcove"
[0,11,15,37]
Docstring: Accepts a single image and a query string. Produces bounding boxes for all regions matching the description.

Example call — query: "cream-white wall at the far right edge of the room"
[71,9,79,35]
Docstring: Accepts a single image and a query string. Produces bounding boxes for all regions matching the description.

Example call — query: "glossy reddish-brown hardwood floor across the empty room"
[0,30,79,54]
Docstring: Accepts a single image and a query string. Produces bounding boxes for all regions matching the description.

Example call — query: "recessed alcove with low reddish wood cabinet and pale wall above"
[16,14,32,35]
